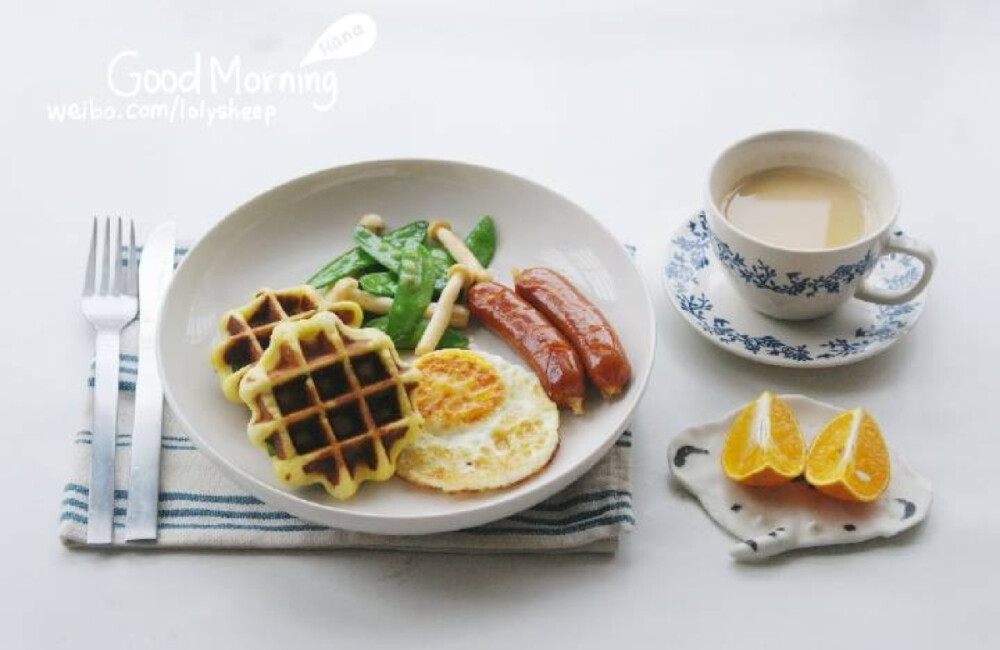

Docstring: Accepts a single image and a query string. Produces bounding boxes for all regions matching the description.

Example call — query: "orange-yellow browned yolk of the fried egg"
[413,350,506,429]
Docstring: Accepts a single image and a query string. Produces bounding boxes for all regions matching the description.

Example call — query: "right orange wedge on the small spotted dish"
[806,407,890,502]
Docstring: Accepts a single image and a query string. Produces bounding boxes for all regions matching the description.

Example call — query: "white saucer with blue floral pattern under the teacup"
[664,212,926,368]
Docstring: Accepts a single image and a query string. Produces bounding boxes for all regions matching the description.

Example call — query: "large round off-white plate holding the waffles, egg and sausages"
[157,160,656,534]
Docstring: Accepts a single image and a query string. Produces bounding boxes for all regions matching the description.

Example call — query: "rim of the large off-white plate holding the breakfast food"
[156,158,658,535]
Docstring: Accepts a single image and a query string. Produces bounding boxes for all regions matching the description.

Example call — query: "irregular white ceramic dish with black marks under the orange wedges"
[667,395,932,562]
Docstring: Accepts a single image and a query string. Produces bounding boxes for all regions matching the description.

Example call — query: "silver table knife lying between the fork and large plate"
[125,221,174,541]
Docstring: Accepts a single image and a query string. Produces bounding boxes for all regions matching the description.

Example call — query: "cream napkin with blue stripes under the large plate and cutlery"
[59,256,635,553]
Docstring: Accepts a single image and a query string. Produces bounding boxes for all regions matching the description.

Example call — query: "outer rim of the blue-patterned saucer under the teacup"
[657,210,929,370]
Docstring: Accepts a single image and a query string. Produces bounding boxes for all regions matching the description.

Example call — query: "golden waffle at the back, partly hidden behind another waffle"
[212,284,364,402]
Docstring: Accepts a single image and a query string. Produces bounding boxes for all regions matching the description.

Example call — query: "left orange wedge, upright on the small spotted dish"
[722,391,806,485]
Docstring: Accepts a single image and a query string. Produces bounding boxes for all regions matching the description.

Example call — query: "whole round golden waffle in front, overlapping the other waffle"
[240,311,423,499]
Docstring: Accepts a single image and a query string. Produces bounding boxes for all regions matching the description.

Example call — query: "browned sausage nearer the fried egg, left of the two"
[466,282,585,415]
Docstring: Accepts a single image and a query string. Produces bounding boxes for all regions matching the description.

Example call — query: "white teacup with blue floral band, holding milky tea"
[705,131,935,320]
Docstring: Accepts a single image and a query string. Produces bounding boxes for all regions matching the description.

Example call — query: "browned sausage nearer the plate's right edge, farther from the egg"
[514,268,632,398]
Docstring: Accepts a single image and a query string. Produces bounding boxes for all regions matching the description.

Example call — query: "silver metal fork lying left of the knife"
[83,217,139,544]
